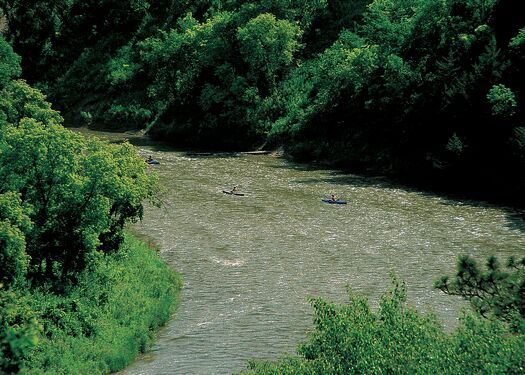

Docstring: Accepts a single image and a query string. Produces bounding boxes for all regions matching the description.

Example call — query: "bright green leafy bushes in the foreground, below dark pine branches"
[245,281,525,374]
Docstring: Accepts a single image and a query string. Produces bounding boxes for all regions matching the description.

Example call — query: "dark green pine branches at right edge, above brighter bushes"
[434,256,525,333]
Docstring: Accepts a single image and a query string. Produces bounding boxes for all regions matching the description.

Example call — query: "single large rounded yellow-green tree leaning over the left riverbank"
[0,118,156,283]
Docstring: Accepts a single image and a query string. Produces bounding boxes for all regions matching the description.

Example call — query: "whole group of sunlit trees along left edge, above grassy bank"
[0,38,156,288]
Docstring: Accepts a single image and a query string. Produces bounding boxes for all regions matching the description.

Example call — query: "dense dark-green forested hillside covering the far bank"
[0,0,525,204]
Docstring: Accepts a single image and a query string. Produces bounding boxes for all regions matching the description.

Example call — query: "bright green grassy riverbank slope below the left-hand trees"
[16,233,182,374]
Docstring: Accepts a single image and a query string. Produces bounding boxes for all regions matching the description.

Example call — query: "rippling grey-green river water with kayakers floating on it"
[84,131,525,375]
